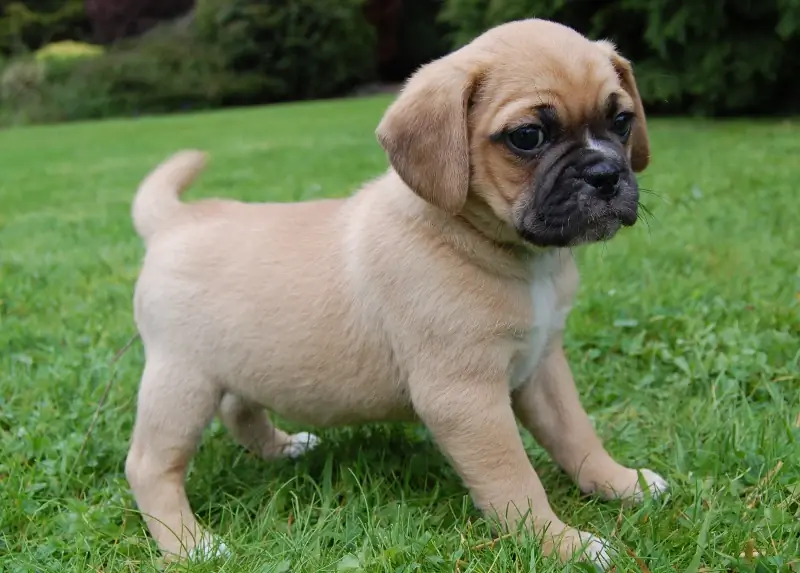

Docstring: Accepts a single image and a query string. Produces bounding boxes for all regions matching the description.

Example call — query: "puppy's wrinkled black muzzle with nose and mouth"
[516,145,639,247]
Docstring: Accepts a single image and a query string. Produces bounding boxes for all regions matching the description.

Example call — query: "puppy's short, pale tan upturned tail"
[131,150,206,243]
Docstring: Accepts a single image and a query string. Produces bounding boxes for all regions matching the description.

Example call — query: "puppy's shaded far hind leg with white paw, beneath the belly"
[219,393,319,460]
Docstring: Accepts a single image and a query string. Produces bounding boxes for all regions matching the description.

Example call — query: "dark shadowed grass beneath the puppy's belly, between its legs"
[187,424,478,523]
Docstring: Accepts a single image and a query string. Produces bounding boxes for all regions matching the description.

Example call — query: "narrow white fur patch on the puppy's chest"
[509,251,570,390]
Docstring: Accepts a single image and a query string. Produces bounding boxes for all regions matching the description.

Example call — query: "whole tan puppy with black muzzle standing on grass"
[126,20,667,566]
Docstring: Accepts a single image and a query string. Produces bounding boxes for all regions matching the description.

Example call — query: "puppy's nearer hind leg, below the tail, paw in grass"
[125,357,224,558]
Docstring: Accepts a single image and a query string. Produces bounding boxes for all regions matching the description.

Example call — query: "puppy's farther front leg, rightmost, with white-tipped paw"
[513,338,668,501]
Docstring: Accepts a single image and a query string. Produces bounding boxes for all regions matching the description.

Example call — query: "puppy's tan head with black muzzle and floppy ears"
[377,20,650,247]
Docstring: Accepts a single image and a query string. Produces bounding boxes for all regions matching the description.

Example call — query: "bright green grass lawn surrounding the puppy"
[0,98,800,573]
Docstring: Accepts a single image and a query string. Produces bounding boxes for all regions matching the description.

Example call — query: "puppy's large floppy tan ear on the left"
[375,51,478,213]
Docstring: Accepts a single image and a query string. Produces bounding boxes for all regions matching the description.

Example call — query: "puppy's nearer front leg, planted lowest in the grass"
[411,370,610,567]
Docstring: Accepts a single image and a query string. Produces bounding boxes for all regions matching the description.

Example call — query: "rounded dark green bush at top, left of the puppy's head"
[193,0,375,103]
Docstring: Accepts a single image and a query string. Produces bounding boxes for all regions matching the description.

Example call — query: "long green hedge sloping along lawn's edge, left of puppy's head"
[0,0,375,123]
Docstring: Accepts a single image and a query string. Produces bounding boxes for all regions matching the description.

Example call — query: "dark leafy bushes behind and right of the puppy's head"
[441,0,800,114]
